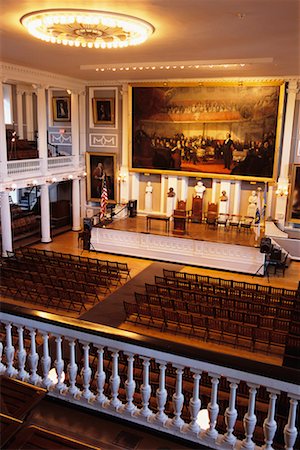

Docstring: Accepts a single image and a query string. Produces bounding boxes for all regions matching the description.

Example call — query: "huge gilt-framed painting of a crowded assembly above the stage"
[130,81,284,181]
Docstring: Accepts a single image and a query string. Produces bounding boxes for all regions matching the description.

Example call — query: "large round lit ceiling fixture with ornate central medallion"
[20,9,154,49]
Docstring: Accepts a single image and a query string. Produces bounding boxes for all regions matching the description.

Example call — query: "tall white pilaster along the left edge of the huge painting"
[116,83,129,203]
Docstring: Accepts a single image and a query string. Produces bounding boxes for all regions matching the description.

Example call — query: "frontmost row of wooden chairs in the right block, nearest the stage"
[163,269,300,298]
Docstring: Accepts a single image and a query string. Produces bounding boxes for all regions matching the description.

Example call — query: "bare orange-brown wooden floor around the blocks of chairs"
[3,231,300,365]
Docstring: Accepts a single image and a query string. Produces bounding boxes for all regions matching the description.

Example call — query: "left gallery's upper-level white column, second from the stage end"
[36,86,48,175]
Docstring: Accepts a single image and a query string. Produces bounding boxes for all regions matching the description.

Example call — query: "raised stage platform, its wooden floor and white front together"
[91,217,265,275]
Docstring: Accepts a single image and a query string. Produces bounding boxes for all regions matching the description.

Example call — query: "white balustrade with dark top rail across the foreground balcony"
[0,305,300,450]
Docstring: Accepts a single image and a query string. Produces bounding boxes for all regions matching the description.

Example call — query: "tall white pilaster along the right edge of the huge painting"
[275,80,298,229]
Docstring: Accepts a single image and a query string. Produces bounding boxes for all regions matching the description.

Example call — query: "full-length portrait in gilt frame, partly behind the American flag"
[86,152,116,203]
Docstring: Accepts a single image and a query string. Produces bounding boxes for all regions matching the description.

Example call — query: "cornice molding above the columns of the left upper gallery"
[0,61,86,89]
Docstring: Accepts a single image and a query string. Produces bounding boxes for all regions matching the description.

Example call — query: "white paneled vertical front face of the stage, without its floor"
[91,228,265,275]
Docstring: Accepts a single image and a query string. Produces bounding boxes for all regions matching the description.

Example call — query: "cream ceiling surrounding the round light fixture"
[0,0,300,81]
